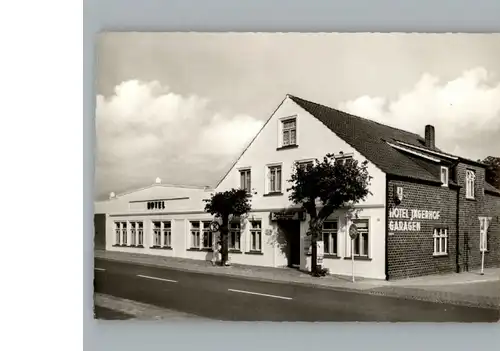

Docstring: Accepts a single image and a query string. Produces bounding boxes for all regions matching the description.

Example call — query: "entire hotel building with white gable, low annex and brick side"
[95,95,500,279]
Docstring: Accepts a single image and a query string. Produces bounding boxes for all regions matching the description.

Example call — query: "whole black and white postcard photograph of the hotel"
[93,32,500,323]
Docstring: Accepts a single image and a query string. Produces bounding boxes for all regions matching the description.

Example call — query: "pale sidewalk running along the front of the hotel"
[94,250,500,310]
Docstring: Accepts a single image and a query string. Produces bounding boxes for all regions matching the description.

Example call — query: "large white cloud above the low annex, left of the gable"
[96,80,263,197]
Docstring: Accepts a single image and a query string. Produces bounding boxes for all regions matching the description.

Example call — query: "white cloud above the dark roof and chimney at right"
[338,67,500,159]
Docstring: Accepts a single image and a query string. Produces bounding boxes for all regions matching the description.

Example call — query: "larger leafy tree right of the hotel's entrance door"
[288,154,372,276]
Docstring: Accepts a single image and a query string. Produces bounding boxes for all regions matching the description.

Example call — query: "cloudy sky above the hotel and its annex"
[94,32,500,200]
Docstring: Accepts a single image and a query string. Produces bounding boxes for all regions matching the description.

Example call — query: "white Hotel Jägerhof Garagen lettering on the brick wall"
[389,208,440,232]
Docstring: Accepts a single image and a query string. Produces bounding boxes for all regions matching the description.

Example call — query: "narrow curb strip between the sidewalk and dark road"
[94,256,500,312]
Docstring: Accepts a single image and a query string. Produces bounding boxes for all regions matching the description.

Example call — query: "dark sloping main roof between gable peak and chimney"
[289,95,448,182]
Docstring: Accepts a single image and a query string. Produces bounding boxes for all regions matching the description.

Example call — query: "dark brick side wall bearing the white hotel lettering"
[387,180,457,279]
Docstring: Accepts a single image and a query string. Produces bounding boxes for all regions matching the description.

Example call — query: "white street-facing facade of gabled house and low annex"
[96,97,386,279]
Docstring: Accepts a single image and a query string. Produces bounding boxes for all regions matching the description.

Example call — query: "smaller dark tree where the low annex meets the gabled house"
[203,189,251,266]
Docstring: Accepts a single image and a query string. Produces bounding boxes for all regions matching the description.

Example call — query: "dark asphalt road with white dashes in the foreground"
[94,259,500,322]
